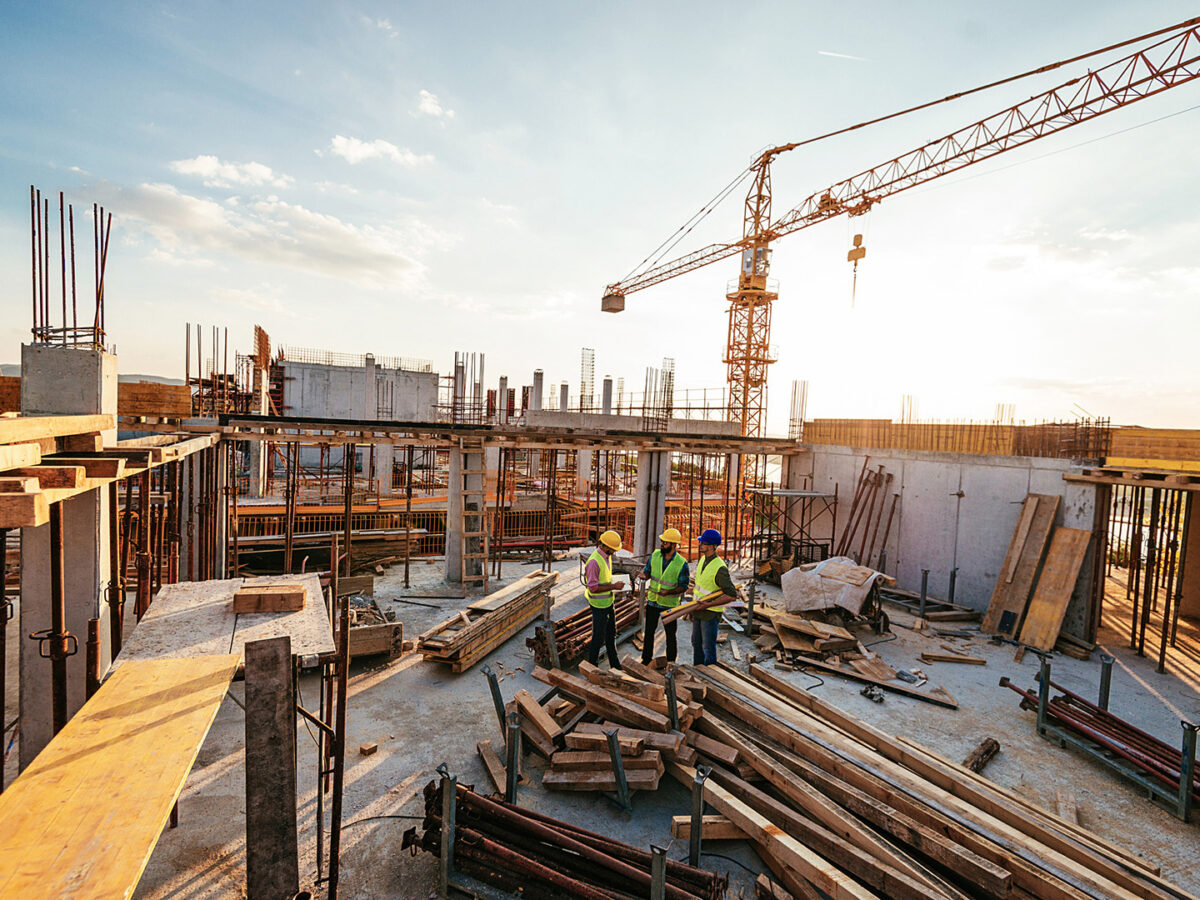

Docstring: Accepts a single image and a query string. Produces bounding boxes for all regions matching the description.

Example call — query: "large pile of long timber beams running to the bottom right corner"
[667,665,1188,900]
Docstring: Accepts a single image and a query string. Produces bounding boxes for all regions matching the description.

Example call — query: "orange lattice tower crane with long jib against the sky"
[600,18,1200,448]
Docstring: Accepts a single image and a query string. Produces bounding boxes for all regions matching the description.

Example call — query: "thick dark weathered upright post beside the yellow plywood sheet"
[246,636,300,900]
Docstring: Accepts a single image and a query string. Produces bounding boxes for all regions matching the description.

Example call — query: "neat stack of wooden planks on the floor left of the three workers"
[416,572,558,673]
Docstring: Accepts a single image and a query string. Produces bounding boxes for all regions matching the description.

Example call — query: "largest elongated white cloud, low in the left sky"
[91,184,436,287]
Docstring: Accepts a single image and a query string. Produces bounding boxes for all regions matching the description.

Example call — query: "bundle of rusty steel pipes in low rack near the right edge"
[1004,682,1200,803]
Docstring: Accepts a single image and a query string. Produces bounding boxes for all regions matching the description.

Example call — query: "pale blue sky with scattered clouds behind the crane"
[0,2,1200,432]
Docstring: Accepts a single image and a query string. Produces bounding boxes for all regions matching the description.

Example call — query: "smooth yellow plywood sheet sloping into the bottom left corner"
[0,654,241,900]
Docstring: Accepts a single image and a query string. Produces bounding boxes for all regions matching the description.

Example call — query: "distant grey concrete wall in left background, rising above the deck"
[280,360,438,422]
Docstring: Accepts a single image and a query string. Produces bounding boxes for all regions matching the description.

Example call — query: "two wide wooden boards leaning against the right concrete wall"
[983,493,1092,659]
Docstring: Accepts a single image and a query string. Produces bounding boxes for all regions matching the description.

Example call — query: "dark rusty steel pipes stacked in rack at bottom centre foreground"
[402,781,728,900]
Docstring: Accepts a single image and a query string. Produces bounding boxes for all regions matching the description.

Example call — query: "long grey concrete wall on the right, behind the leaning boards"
[797,445,1096,635]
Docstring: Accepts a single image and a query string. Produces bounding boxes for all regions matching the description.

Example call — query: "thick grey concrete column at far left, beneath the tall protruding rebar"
[19,344,116,769]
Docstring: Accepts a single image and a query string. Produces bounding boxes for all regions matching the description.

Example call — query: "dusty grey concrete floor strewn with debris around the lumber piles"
[7,559,1185,900]
